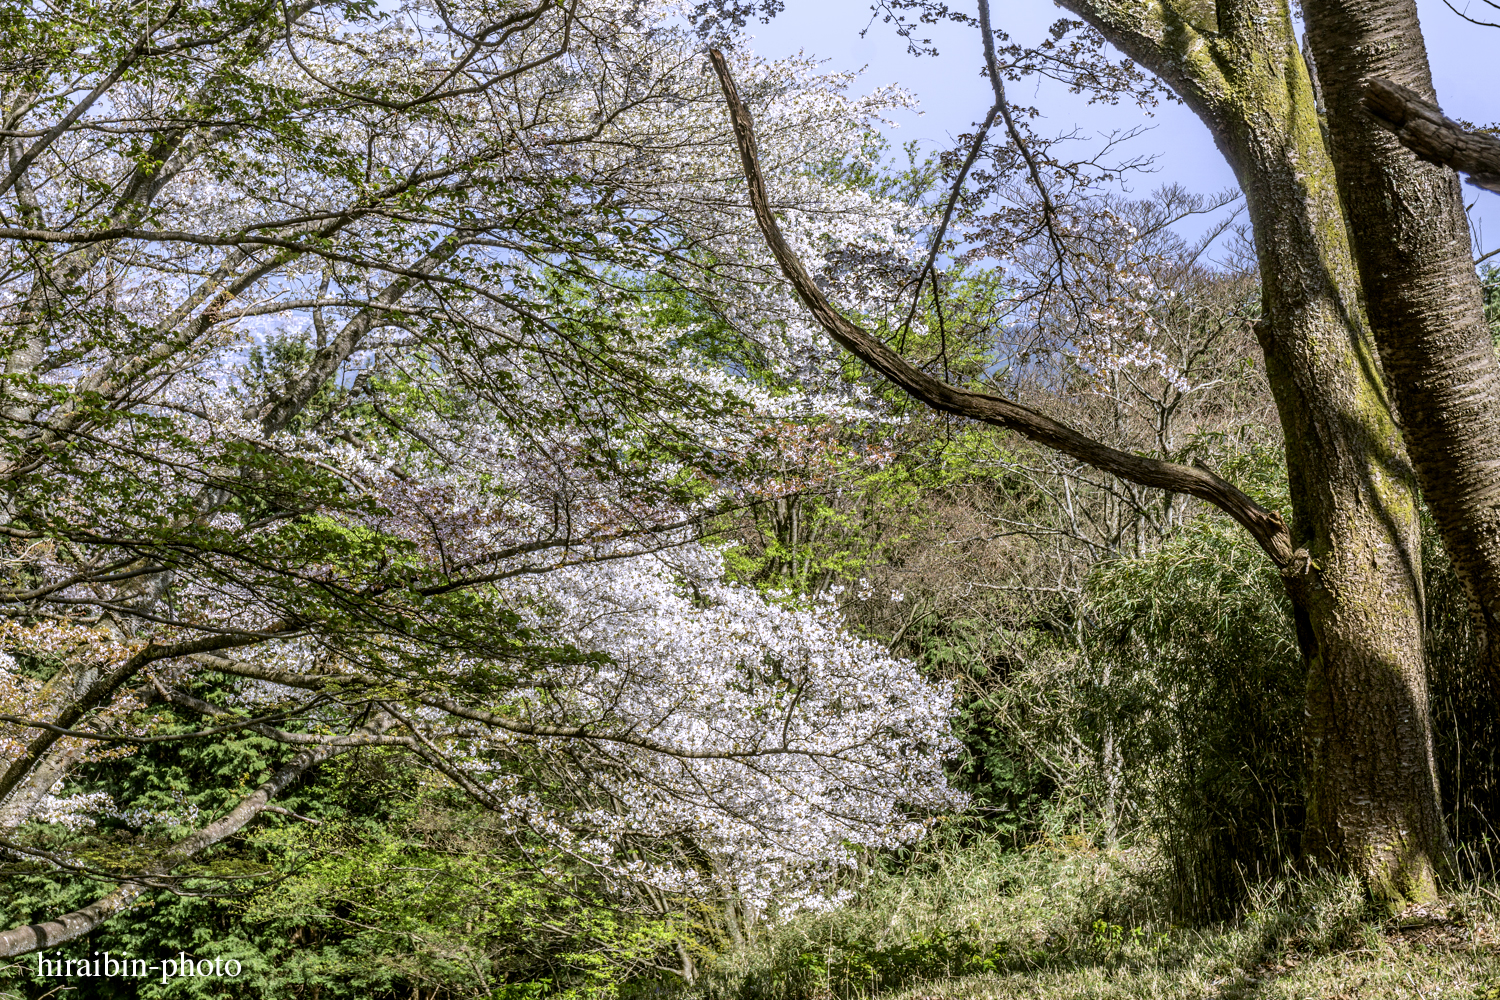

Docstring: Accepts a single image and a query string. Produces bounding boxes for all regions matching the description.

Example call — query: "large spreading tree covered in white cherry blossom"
[0,0,962,955]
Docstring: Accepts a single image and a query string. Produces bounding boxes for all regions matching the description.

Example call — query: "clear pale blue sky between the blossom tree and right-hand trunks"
[750,0,1500,262]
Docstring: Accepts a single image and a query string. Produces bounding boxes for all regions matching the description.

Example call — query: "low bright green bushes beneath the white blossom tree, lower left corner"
[0,680,714,1000]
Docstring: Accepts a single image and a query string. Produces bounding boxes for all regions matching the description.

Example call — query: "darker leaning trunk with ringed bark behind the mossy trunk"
[1302,0,1500,690]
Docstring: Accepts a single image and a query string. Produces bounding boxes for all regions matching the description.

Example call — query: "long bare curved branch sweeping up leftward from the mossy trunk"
[710,49,1305,570]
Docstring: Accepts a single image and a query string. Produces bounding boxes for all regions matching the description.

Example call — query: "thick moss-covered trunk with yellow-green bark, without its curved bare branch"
[1062,0,1448,900]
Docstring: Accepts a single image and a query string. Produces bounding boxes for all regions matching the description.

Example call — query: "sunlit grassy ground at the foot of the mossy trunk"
[704,843,1500,1000]
